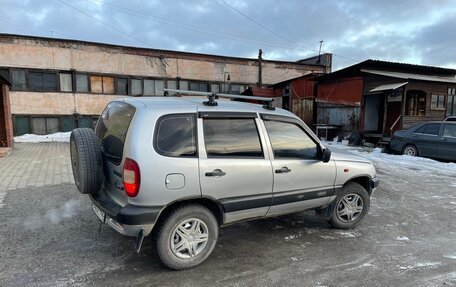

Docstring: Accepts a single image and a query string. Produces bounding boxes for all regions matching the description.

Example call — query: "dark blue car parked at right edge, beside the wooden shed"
[390,121,456,161]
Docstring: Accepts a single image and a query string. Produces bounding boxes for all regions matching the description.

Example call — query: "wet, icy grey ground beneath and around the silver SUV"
[0,151,456,286]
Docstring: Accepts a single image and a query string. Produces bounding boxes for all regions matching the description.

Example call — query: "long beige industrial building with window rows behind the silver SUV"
[0,34,331,145]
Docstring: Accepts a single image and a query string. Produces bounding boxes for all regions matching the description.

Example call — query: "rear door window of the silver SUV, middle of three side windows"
[203,118,264,158]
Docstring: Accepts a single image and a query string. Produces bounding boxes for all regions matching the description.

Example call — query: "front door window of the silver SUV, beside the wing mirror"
[264,121,319,159]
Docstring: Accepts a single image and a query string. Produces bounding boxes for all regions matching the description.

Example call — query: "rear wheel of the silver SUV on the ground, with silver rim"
[156,205,218,270]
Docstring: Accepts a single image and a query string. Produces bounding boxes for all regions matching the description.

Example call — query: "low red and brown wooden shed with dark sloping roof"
[316,60,456,141]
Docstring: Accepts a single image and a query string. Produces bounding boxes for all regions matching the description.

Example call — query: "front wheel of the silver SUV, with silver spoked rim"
[328,182,370,229]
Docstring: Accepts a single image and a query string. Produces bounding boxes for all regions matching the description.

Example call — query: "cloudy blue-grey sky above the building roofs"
[0,0,456,70]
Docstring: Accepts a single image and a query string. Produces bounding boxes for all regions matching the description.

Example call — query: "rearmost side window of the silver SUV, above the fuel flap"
[154,114,196,157]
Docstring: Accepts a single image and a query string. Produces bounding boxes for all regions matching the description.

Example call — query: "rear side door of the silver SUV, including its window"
[198,112,272,222]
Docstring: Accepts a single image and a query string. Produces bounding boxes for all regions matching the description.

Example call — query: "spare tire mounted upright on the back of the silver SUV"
[70,128,103,194]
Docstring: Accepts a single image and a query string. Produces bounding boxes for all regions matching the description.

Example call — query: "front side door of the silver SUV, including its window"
[264,117,336,215]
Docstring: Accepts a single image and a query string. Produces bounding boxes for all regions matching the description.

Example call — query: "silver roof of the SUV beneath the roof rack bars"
[117,96,297,118]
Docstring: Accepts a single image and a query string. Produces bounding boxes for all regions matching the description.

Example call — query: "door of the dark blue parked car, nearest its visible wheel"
[412,123,441,157]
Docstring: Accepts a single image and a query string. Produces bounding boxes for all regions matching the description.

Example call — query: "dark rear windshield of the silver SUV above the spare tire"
[95,102,135,165]
